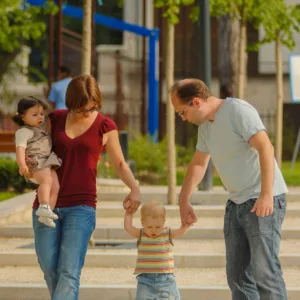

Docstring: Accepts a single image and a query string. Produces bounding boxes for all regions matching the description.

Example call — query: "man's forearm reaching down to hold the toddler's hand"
[179,151,210,225]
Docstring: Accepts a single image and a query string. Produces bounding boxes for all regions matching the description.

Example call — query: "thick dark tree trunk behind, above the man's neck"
[218,15,233,91]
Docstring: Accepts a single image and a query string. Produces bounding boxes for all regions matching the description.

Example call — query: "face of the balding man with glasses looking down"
[171,92,206,125]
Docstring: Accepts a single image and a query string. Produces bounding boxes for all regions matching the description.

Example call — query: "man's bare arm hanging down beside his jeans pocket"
[249,130,275,217]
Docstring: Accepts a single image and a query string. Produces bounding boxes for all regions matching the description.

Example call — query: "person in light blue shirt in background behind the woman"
[48,66,72,109]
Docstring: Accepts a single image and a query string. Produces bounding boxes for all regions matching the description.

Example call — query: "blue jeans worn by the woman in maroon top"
[32,206,96,300]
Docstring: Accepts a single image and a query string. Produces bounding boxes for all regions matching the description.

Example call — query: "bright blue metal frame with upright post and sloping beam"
[27,0,159,141]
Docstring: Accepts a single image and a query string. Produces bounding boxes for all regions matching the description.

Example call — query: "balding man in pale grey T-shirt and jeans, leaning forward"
[171,79,288,300]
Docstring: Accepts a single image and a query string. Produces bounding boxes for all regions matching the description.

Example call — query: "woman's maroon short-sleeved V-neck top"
[33,109,117,208]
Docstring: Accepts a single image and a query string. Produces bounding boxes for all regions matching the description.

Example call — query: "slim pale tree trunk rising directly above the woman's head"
[81,0,92,75]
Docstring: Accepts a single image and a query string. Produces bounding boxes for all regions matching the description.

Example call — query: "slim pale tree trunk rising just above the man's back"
[237,20,247,99]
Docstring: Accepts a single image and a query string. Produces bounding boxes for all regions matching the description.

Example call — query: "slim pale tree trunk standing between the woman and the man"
[165,22,176,204]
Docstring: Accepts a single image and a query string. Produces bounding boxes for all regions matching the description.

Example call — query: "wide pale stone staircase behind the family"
[0,187,300,300]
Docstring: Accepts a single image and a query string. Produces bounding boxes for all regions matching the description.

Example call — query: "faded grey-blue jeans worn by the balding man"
[224,194,288,300]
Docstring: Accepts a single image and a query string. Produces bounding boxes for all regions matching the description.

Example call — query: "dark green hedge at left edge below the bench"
[0,157,36,193]
